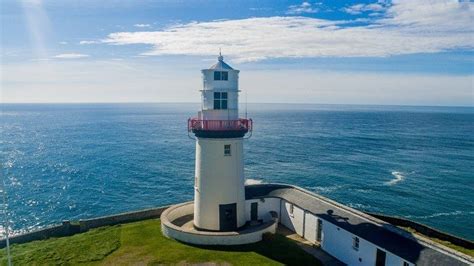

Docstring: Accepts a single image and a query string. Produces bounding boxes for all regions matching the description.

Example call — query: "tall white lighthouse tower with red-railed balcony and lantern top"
[188,53,252,231]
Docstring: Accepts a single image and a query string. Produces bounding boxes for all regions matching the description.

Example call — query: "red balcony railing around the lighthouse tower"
[188,118,252,132]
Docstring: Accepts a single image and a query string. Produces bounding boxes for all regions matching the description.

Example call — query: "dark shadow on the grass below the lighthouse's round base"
[184,234,323,265]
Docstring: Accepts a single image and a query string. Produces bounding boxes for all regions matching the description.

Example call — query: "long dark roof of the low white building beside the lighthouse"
[245,184,468,266]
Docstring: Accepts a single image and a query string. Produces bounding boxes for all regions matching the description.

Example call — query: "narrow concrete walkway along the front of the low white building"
[277,224,346,266]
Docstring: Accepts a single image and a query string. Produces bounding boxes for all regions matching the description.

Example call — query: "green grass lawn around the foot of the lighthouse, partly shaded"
[0,220,321,265]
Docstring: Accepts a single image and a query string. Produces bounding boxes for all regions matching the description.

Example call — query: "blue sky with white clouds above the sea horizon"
[0,0,474,106]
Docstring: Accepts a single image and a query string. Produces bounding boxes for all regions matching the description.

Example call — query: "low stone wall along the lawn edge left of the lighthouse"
[0,206,169,248]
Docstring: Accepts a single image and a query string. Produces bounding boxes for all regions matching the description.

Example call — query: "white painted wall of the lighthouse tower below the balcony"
[194,138,247,230]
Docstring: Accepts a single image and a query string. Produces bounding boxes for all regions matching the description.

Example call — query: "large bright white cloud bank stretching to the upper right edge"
[95,0,474,62]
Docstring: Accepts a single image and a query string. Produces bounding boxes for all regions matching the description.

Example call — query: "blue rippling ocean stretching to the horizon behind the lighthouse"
[0,104,474,240]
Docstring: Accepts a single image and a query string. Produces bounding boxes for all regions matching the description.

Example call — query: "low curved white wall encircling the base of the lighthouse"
[161,202,278,245]
